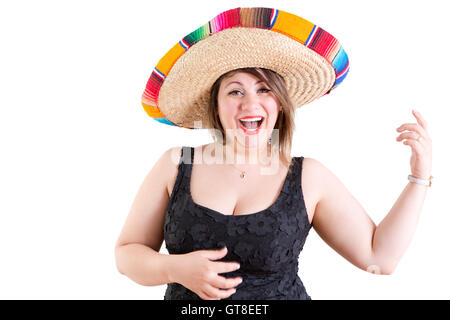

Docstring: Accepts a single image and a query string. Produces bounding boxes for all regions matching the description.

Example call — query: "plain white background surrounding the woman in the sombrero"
[0,0,450,299]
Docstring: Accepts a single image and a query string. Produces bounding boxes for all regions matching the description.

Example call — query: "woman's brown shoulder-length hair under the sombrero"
[208,68,295,168]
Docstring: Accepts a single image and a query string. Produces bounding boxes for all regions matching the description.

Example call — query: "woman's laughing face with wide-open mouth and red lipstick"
[217,72,280,148]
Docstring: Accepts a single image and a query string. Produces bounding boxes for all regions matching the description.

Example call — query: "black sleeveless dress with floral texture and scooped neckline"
[164,147,311,300]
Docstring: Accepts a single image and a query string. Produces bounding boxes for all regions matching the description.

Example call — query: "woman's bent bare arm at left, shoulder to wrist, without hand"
[115,149,181,286]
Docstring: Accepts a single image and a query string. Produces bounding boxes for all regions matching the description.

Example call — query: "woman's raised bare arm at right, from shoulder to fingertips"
[305,112,431,274]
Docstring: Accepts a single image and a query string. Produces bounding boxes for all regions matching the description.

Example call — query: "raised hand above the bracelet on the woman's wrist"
[397,110,431,180]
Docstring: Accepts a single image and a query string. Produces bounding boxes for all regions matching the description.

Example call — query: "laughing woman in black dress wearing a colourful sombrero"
[116,8,431,299]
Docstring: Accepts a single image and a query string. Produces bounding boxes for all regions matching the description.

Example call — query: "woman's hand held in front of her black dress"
[170,247,242,300]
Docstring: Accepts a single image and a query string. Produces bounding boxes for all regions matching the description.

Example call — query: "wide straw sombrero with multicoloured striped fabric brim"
[142,8,349,129]
